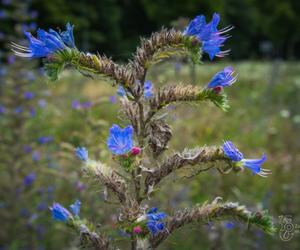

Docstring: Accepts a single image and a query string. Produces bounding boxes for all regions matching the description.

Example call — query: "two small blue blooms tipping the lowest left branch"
[50,200,81,222]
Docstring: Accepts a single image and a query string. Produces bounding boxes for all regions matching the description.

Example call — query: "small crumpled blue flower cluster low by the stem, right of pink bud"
[147,207,167,235]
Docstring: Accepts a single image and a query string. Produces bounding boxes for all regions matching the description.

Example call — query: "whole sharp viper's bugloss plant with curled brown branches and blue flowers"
[13,14,275,249]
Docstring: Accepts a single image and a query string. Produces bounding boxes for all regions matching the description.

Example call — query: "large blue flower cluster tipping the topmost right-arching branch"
[183,13,232,60]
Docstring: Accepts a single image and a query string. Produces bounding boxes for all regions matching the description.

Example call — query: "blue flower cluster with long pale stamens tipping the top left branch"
[12,23,75,58]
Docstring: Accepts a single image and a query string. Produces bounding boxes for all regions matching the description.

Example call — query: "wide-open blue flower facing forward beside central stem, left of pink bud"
[107,124,133,155]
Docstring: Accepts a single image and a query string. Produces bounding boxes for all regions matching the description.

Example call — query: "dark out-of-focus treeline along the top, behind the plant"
[2,0,300,59]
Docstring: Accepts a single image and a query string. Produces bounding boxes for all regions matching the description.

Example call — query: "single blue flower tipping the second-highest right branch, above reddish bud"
[207,66,237,89]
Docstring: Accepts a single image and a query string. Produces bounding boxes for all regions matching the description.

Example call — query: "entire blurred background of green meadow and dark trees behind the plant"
[0,0,300,250]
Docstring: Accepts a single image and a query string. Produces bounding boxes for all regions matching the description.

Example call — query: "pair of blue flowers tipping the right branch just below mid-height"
[223,141,270,177]
